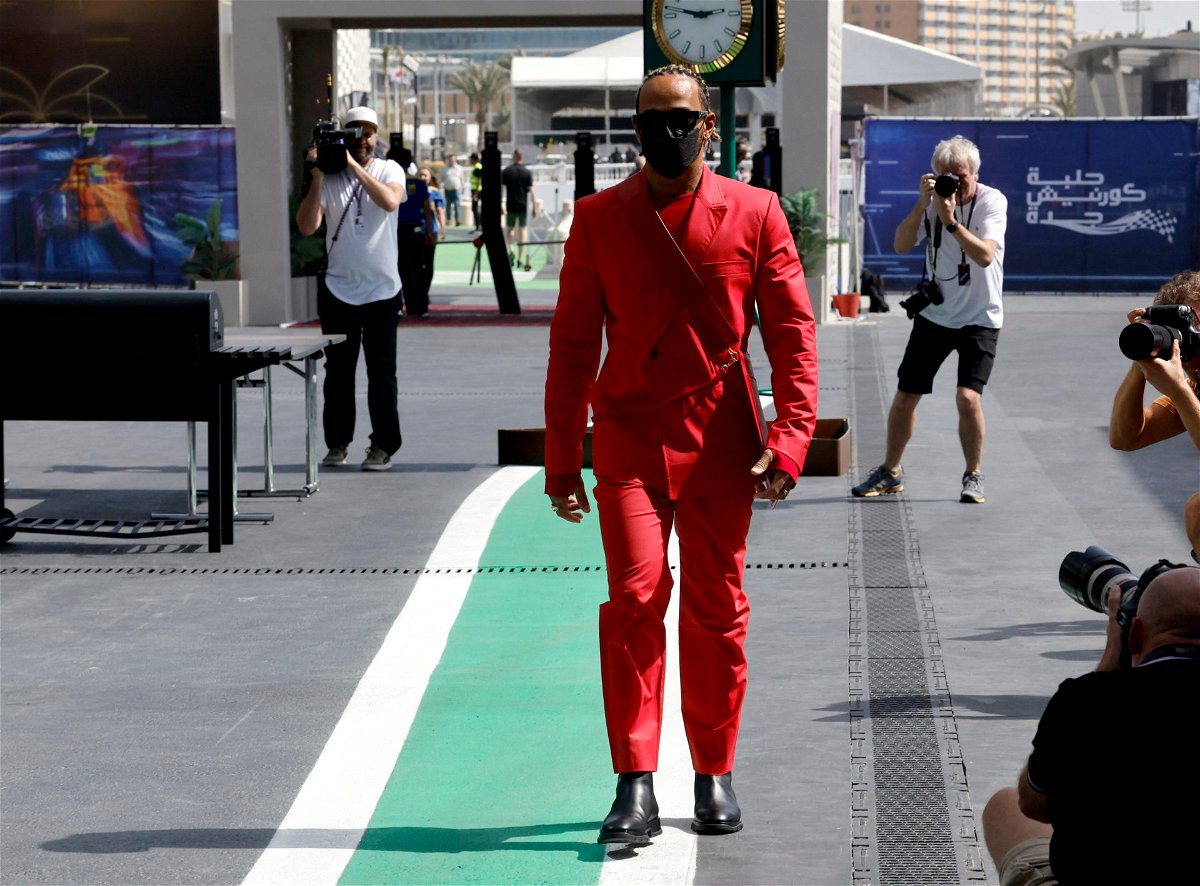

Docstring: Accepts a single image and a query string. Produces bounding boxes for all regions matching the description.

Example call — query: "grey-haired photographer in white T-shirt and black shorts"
[852,136,1008,504]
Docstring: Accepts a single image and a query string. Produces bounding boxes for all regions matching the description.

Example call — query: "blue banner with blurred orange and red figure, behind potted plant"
[0,126,238,280]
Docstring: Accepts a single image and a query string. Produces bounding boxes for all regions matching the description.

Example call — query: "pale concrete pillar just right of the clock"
[779,0,842,322]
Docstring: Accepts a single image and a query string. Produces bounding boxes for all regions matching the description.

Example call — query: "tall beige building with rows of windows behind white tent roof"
[845,0,1075,116]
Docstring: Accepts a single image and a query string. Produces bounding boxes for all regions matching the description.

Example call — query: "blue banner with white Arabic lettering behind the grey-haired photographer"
[863,119,1200,293]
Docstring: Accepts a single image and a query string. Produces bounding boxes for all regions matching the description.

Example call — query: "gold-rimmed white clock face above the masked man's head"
[650,0,754,73]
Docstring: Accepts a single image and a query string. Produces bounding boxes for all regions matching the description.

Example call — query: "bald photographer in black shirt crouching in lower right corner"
[983,567,1200,886]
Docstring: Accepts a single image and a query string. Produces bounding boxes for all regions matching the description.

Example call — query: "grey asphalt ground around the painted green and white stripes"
[0,288,1200,885]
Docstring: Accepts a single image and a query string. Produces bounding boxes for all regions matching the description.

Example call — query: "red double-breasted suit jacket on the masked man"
[546,168,817,497]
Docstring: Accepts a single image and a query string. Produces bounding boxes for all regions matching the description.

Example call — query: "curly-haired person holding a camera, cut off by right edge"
[1109,270,1200,559]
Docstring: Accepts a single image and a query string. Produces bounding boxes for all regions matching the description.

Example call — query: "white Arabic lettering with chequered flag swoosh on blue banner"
[1025,166,1178,243]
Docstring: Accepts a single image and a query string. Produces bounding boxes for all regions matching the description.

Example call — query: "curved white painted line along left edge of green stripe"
[244,467,540,886]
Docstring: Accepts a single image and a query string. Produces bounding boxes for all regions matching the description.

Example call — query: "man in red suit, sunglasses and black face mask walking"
[546,66,817,844]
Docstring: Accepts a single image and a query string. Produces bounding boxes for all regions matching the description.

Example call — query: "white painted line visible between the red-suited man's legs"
[600,529,696,886]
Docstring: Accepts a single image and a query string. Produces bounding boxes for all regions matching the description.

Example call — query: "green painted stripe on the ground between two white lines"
[341,474,612,884]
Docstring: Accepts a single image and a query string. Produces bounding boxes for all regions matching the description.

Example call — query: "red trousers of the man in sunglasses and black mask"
[595,479,752,776]
